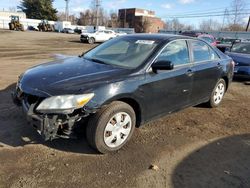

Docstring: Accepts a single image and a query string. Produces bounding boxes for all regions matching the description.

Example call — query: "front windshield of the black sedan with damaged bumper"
[83,37,158,68]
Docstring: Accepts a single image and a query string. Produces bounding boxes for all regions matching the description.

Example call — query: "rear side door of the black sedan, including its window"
[188,40,222,104]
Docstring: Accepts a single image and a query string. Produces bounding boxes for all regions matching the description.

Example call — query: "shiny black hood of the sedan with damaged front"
[19,57,130,97]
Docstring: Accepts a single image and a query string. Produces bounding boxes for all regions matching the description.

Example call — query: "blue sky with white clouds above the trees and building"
[0,0,250,26]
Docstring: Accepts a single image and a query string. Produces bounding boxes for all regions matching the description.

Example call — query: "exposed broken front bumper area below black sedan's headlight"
[12,90,89,140]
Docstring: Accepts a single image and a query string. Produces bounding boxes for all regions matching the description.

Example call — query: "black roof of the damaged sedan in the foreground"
[121,33,193,40]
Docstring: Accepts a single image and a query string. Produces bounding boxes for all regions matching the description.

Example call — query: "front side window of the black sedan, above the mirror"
[158,40,189,66]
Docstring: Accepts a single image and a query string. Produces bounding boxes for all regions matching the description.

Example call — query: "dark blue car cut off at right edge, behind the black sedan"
[226,42,250,79]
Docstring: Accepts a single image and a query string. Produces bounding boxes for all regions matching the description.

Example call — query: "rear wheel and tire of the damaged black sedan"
[208,78,227,108]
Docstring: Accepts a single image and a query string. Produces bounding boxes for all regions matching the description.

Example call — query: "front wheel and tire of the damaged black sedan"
[86,101,136,153]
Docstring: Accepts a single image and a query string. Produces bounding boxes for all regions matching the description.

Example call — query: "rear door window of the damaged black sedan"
[191,41,211,62]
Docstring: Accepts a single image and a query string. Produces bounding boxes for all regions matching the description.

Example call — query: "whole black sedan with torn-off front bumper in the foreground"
[13,34,233,153]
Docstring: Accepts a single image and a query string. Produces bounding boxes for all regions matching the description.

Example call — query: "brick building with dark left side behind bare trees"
[118,8,165,33]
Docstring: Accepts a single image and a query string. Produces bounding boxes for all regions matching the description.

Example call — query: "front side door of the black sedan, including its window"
[142,40,193,119]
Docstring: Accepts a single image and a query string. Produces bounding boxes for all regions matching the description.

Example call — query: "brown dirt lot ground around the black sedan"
[0,31,250,188]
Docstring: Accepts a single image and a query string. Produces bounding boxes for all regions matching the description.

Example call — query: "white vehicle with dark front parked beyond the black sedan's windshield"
[80,30,117,44]
